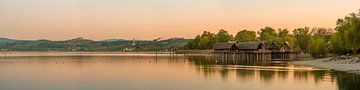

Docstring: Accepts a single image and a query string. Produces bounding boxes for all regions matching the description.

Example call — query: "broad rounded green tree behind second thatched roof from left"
[235,30,259,42]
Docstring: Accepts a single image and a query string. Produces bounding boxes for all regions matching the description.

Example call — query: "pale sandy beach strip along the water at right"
[289,57,360,74]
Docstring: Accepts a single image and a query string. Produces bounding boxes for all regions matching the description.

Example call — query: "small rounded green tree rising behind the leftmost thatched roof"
[216,29,234,42]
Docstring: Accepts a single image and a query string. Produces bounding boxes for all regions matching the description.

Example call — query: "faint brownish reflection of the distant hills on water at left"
[0,56,186,67]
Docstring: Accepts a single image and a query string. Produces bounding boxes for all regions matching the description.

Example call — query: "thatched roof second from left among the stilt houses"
[237,42,263,50]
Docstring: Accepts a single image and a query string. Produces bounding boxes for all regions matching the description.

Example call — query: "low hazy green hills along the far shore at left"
[0,38,188,51]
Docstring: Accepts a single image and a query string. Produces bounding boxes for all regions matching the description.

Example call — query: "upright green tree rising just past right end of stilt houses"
[293,27,311,51]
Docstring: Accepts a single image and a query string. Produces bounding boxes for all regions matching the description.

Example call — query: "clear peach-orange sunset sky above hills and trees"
[0,0,360,40]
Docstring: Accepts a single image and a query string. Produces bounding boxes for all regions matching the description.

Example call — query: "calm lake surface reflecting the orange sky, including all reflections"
[0,56,360,90]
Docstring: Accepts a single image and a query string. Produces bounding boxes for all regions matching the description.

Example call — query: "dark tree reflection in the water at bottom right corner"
[335,72,360,90]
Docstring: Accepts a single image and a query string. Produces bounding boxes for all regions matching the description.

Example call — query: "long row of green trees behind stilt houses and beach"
[184,10,360,57]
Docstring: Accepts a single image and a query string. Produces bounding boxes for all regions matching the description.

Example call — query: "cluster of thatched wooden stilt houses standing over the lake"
[212,42,297,62]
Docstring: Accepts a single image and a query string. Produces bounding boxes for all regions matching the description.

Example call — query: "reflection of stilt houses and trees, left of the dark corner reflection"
[187,57,340,84]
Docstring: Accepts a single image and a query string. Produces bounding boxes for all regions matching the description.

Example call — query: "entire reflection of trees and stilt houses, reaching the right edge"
[188,57,360,90]
